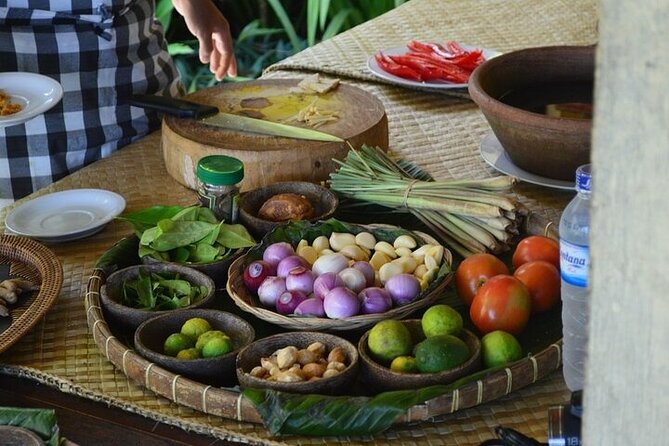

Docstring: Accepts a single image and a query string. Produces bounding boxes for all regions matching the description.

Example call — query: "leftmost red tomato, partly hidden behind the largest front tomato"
[455,254,509,305]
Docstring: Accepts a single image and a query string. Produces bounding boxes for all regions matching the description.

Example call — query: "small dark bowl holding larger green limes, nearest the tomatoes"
[358,319,481,391]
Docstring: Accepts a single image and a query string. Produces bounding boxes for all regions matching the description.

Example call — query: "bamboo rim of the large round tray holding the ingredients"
[85,215,562,423]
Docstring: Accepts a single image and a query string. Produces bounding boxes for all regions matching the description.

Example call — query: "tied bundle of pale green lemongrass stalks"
[329,145,525,257]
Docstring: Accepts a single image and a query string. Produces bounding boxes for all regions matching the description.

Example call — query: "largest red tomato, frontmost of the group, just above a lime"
[469,274,532,335]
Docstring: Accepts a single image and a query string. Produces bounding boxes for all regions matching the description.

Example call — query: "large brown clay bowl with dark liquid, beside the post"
[469,46,595,180]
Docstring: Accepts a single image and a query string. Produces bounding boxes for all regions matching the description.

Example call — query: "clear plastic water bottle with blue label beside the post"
[560,164,590,392]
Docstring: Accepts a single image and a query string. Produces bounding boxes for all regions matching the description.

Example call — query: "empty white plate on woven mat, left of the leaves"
[5,189,125,242]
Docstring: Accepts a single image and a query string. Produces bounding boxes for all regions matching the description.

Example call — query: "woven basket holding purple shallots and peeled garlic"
[227,221,453,331]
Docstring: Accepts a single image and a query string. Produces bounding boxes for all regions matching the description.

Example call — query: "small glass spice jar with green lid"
[196,155,244,223]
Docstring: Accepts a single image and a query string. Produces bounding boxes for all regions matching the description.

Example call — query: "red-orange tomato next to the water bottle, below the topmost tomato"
[513,260,560,312]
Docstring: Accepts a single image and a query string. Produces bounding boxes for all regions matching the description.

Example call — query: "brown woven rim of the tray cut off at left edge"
[0,234,63,353]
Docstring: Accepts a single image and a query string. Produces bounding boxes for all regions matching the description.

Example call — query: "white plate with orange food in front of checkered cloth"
[0,72,63,128]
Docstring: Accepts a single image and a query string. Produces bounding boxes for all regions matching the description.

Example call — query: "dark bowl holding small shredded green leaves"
[100,263,216,332]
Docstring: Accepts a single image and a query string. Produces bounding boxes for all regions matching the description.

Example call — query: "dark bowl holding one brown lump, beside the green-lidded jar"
[239,182,339,238]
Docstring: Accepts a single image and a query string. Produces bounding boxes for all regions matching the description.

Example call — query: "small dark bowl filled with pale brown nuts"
[237,331,358,395]
